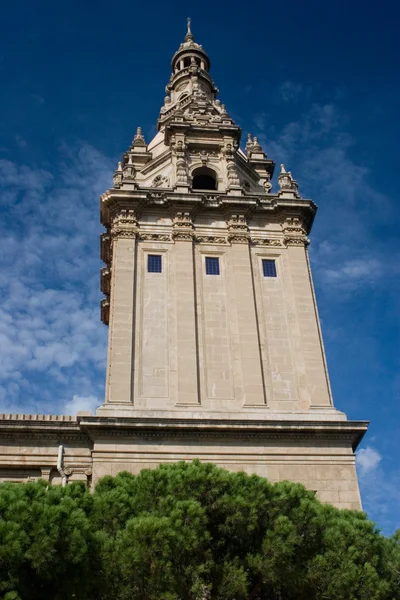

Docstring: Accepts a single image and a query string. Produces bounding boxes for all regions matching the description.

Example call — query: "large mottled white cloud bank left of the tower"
[0,144,112,413]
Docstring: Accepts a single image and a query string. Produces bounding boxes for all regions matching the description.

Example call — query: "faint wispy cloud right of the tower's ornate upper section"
[254,95,400,299]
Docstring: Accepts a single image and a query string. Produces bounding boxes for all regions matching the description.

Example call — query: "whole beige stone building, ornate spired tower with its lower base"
[0,23,367,508]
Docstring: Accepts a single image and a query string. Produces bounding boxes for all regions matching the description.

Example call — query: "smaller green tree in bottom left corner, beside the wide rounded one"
[0,481,98,600]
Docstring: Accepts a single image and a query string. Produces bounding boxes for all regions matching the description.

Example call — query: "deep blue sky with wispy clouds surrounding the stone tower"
[0,0,400,533]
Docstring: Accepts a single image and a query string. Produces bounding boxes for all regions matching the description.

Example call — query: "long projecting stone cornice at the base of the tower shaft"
[0,415,368,450]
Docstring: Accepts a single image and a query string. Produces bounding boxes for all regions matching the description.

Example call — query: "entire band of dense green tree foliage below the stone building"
[0,461,400,600]
